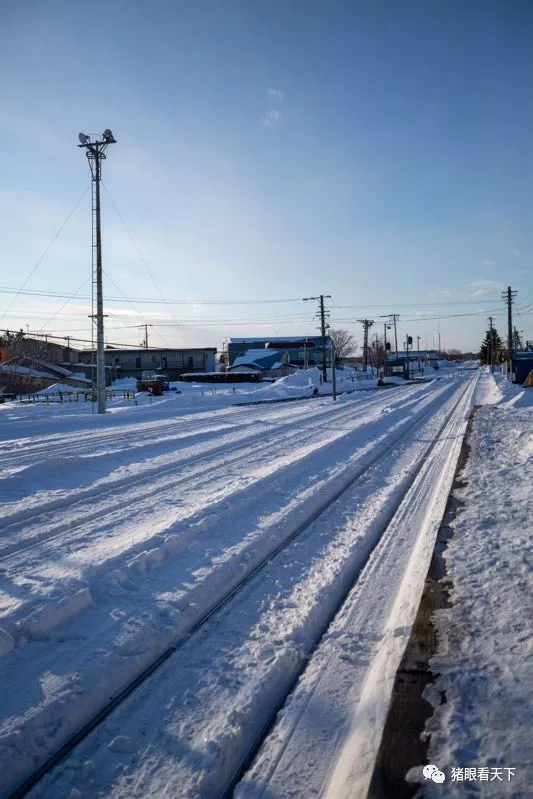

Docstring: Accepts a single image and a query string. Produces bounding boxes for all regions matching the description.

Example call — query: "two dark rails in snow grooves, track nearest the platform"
[2,376,472,799]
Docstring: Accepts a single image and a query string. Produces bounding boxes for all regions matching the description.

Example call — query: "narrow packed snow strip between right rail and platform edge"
[236,376,472,799]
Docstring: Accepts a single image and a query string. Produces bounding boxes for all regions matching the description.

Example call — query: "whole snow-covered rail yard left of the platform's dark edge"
[4,368,526,799]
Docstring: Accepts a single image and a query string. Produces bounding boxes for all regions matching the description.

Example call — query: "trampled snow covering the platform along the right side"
[413,375,533,799]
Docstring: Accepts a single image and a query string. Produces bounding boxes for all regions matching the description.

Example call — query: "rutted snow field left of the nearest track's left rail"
[0,376,462,790]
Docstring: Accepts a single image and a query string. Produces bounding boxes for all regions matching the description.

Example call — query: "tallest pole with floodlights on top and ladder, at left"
[78,128,115,413]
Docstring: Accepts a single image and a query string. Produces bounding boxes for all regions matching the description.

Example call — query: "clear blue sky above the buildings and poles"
[0,0,533,349]
